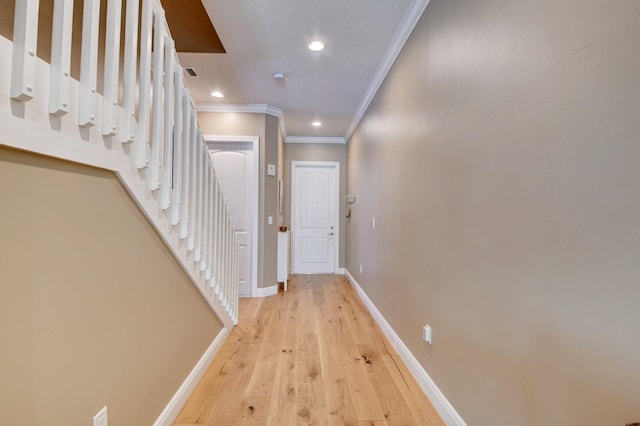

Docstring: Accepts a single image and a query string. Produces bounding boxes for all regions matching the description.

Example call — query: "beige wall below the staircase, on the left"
[0,147,222,425]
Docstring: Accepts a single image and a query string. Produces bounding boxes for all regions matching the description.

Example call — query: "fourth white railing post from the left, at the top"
[102,0,122,136]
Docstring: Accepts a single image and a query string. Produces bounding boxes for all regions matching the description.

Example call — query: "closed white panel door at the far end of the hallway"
[291,161,339,274]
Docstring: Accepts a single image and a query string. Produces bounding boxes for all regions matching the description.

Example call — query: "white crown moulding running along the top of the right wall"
[344,0,430,141]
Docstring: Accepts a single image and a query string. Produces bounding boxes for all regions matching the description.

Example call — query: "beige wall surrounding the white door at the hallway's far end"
[284,143,347,268]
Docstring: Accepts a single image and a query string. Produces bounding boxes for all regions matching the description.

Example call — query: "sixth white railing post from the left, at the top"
[132,0,154,169]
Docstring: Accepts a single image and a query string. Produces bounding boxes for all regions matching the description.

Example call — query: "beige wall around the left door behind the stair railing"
[198,112,279,288]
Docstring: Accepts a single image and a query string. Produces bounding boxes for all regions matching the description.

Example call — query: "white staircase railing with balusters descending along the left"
[0,0,238,326]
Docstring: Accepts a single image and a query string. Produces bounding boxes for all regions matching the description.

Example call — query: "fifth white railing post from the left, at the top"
[120,0,139,143]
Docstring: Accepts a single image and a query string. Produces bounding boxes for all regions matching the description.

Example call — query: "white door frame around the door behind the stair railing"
[203,135,260,297]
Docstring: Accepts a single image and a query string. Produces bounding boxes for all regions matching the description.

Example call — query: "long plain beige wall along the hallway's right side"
[347,0,640,425]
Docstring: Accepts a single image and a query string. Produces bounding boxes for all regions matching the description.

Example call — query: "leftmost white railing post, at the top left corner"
[11,0,40,102]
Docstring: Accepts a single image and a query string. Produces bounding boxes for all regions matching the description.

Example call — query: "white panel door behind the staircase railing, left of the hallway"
[207,141,257,296]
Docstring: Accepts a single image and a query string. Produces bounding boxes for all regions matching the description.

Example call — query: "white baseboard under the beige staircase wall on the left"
[153,327,230,426]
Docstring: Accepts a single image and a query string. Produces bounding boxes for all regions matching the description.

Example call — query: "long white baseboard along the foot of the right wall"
[345,270,467,426]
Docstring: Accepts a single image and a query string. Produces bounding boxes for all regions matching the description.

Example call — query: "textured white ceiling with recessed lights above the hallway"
[179,0,428,142]
